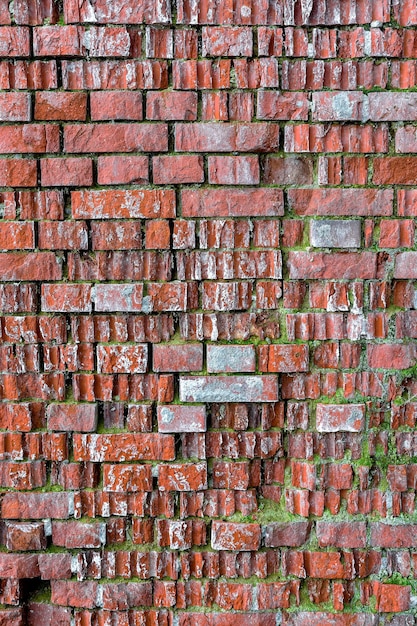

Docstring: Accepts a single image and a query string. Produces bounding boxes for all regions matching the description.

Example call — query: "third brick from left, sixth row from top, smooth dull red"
[96,155,149,185]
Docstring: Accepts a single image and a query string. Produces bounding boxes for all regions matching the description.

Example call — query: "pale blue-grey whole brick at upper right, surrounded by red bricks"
[310,220,361,248]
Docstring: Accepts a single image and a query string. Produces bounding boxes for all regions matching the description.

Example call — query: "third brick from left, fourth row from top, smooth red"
[90,91,143,120]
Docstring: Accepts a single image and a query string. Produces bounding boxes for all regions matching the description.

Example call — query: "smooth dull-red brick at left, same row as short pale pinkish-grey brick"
[46,404,97,433]
